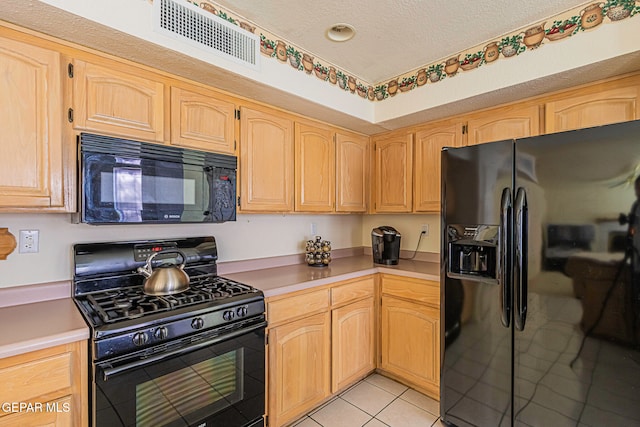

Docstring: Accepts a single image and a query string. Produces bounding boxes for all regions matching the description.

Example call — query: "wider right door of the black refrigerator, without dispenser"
[514,118,640,426]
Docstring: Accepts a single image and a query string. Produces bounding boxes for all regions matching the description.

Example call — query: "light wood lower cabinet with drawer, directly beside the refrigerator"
[380,275,440,399]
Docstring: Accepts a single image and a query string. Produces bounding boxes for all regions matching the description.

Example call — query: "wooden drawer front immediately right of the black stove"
[267,289,329,325]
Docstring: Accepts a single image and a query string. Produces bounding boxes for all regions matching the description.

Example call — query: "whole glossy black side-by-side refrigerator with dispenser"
[440,121,640,427]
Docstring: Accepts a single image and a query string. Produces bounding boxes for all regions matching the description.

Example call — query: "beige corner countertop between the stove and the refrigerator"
[224,255,440,297]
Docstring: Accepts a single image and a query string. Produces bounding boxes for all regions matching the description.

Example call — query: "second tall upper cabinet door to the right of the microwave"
[294,123,336,212]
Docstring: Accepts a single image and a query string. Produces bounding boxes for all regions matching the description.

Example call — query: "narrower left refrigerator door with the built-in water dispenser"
[440,141,513,427]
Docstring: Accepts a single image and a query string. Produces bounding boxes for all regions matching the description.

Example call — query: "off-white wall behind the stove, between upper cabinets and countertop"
[0,214,360,288]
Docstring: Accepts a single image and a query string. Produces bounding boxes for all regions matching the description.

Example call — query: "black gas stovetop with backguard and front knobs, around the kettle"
[74,237,264,360]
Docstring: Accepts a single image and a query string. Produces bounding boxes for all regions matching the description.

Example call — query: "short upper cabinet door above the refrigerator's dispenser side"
[467,105,540,145]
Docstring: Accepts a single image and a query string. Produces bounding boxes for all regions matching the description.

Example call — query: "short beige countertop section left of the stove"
[0,298,89,359]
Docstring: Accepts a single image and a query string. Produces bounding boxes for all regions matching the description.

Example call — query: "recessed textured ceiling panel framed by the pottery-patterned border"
[214,0,585,83]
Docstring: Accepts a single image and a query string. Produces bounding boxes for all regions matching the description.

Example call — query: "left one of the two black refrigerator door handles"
[498,188,513,328]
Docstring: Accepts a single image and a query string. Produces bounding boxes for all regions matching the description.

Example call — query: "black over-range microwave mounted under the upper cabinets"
[77,133,237,224]
